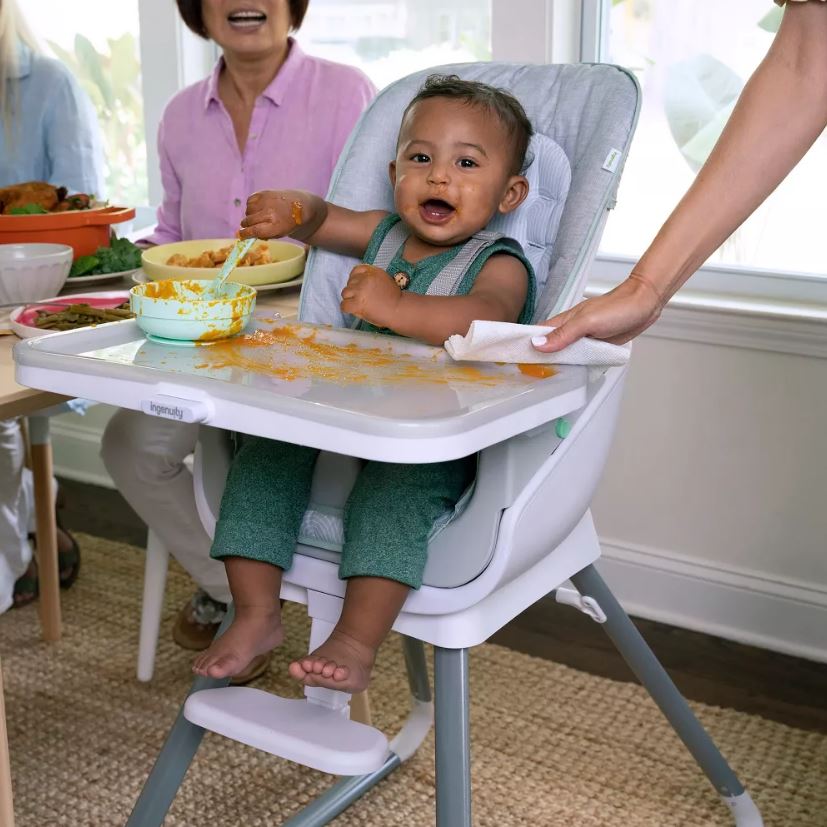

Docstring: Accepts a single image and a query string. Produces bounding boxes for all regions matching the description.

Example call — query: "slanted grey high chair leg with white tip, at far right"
[572,566,764,827]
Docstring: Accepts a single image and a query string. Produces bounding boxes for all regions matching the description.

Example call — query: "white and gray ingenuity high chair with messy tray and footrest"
[16,63,762,827]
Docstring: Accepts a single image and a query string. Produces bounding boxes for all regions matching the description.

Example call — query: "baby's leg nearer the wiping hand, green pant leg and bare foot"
[290,457,476,692]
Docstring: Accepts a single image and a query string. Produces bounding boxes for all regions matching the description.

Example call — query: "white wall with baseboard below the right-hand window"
[594,326,827,661]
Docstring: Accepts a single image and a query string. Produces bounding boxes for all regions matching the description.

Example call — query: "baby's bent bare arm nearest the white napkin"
[342,254,528,345]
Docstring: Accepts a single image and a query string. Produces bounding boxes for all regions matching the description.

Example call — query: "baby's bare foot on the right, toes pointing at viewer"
[288,629,376,693]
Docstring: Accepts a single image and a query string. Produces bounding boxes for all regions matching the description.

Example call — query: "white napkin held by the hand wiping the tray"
[445,321,631,368]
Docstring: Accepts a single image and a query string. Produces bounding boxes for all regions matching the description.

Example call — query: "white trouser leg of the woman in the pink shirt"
[101,409,230,603]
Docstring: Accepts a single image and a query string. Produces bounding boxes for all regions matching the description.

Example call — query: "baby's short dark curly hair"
[402,75,534,174]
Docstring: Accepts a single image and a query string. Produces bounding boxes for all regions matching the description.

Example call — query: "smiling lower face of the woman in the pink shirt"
[201,0,292,57]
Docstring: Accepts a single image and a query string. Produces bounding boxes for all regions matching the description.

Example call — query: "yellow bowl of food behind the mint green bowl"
[141,238,305,285]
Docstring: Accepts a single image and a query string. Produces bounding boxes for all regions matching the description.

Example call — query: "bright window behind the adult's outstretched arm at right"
[583,0,827,298]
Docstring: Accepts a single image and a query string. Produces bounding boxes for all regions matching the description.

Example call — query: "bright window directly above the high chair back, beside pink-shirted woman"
[297,0,491,89]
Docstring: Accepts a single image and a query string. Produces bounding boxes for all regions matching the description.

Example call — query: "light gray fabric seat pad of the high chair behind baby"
[246,63,638,586]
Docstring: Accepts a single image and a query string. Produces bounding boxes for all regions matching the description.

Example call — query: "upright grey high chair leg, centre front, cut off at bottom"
[434,646,471,827]
